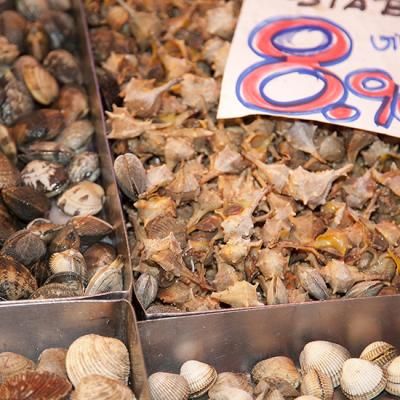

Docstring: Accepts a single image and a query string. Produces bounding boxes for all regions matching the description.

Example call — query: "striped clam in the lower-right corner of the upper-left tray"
[85,256,124,296]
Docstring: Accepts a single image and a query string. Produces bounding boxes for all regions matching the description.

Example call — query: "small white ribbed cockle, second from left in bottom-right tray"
[180,360,218,398]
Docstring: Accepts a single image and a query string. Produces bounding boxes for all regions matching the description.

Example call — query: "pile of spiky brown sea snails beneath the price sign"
[85,0,400,313]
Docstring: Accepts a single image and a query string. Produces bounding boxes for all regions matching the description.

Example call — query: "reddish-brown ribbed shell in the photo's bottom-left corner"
[0,371,72,400]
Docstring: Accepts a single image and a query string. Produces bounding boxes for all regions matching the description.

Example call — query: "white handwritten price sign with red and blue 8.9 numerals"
[218,0,400,137]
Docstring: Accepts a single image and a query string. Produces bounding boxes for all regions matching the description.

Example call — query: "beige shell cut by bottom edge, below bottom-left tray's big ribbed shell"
[71,375,136,400]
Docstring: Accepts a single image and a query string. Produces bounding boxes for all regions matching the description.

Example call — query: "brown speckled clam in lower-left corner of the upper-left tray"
[0,256,37,300]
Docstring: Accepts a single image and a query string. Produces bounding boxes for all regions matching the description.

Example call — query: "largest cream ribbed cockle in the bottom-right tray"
[300,340,350,387]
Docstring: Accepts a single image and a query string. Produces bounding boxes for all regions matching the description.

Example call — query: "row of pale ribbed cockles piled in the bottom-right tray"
[149,340,400,400]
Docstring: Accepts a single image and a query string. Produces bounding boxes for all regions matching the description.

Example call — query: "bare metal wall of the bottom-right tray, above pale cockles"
[138,296,400,399]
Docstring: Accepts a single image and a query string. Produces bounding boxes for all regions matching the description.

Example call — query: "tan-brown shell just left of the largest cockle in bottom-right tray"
[251,356,301,388]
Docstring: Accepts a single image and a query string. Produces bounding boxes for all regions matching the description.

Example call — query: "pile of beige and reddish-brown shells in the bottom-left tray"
[0,334,135,400]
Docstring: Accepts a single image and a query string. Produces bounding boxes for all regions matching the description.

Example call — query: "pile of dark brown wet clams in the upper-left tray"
[0,0,123,300]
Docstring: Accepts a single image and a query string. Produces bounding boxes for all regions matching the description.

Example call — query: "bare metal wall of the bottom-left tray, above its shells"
[0,300,150,400]
